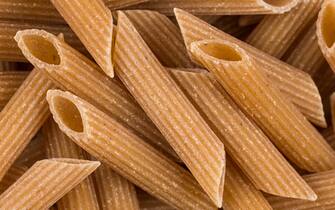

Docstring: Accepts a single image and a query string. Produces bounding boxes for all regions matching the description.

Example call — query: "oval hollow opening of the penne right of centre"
[199,42,242,61]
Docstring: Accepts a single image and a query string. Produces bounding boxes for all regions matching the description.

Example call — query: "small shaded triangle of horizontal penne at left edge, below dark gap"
[0,71,28,110]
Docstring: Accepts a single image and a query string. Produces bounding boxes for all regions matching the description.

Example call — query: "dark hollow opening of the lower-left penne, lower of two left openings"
[53,96,84,132]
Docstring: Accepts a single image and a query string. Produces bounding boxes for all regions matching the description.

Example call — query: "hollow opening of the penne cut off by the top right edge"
[321,3,335,48]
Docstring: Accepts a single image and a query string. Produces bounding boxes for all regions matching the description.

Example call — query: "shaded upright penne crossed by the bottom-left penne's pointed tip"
[42,118,99,210]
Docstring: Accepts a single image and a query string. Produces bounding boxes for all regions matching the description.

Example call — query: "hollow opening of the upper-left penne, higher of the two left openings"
[23,35,60,65]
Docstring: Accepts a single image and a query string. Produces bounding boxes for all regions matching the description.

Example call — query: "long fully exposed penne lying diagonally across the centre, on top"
[113,12,225,207]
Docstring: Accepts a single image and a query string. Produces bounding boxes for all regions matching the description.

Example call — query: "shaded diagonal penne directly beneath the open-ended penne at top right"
[246,0,323,58]
